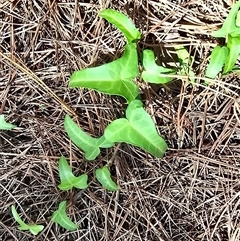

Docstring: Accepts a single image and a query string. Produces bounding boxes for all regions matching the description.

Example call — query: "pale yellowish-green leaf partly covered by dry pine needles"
[174,46,195,82]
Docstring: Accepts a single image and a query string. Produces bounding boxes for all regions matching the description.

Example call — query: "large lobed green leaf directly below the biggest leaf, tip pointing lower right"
[104,100,167,157]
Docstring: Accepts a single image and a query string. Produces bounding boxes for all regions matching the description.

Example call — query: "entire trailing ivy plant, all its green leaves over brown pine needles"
[10,4,240,235]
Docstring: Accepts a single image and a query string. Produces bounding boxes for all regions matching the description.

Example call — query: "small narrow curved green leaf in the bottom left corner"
[11,205,44,235]
